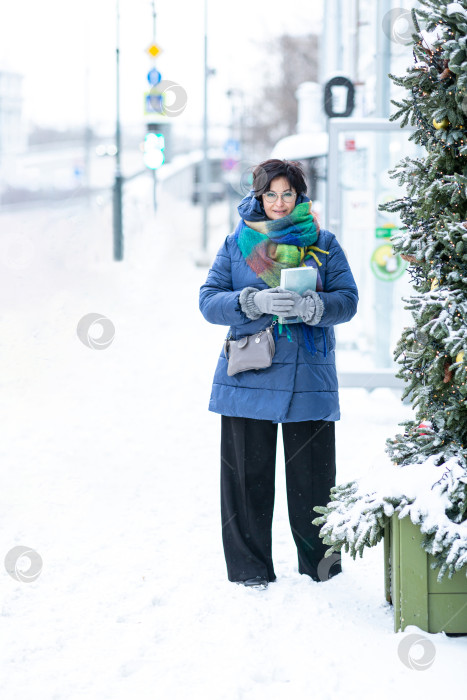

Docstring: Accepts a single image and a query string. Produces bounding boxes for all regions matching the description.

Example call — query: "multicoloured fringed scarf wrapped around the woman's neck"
[235,201,328,289]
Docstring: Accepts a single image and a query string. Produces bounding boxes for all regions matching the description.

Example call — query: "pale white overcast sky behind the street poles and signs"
[0,0,322,133]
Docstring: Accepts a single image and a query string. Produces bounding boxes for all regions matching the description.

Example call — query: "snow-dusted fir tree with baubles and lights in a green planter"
[314,0,467,580]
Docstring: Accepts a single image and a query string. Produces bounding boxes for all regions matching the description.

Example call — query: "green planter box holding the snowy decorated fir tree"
[384,514,467,633]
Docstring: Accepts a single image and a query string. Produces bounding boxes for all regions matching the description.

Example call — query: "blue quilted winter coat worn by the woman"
[199,230,358,423]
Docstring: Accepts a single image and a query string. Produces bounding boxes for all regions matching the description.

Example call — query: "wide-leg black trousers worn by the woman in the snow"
[221,416,341,581]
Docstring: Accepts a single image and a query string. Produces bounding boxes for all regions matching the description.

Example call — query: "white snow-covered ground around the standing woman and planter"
[0,181,467,700]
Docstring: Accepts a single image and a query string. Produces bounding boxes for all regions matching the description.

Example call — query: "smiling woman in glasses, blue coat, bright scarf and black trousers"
[200,159,358,588]
